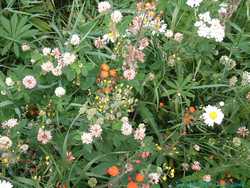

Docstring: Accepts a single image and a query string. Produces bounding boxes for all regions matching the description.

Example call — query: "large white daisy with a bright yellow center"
[202,105,224,126]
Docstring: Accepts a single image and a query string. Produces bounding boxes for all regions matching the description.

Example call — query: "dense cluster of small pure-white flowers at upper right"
[194,12,225,42]
